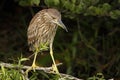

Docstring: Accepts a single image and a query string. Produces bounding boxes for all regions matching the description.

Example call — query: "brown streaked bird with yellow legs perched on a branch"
[26,8,68,75]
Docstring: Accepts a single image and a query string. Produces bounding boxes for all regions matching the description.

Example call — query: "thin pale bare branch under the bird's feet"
[0,62,82,80]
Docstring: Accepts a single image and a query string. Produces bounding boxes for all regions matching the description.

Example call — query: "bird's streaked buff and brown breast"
[36,22,57,46]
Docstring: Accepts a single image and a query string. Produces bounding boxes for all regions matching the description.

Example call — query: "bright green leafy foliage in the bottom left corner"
[0,58,27,80]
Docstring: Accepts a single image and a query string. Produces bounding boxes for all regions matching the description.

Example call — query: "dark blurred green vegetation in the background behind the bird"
[0,0,120,80]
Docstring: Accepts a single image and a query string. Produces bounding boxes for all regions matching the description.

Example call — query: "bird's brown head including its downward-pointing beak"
[47,9,68,32]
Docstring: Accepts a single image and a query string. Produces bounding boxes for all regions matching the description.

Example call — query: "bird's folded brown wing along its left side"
[27,12,41,50]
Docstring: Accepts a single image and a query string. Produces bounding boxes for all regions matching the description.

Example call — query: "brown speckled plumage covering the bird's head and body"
[27,9,61,51]
